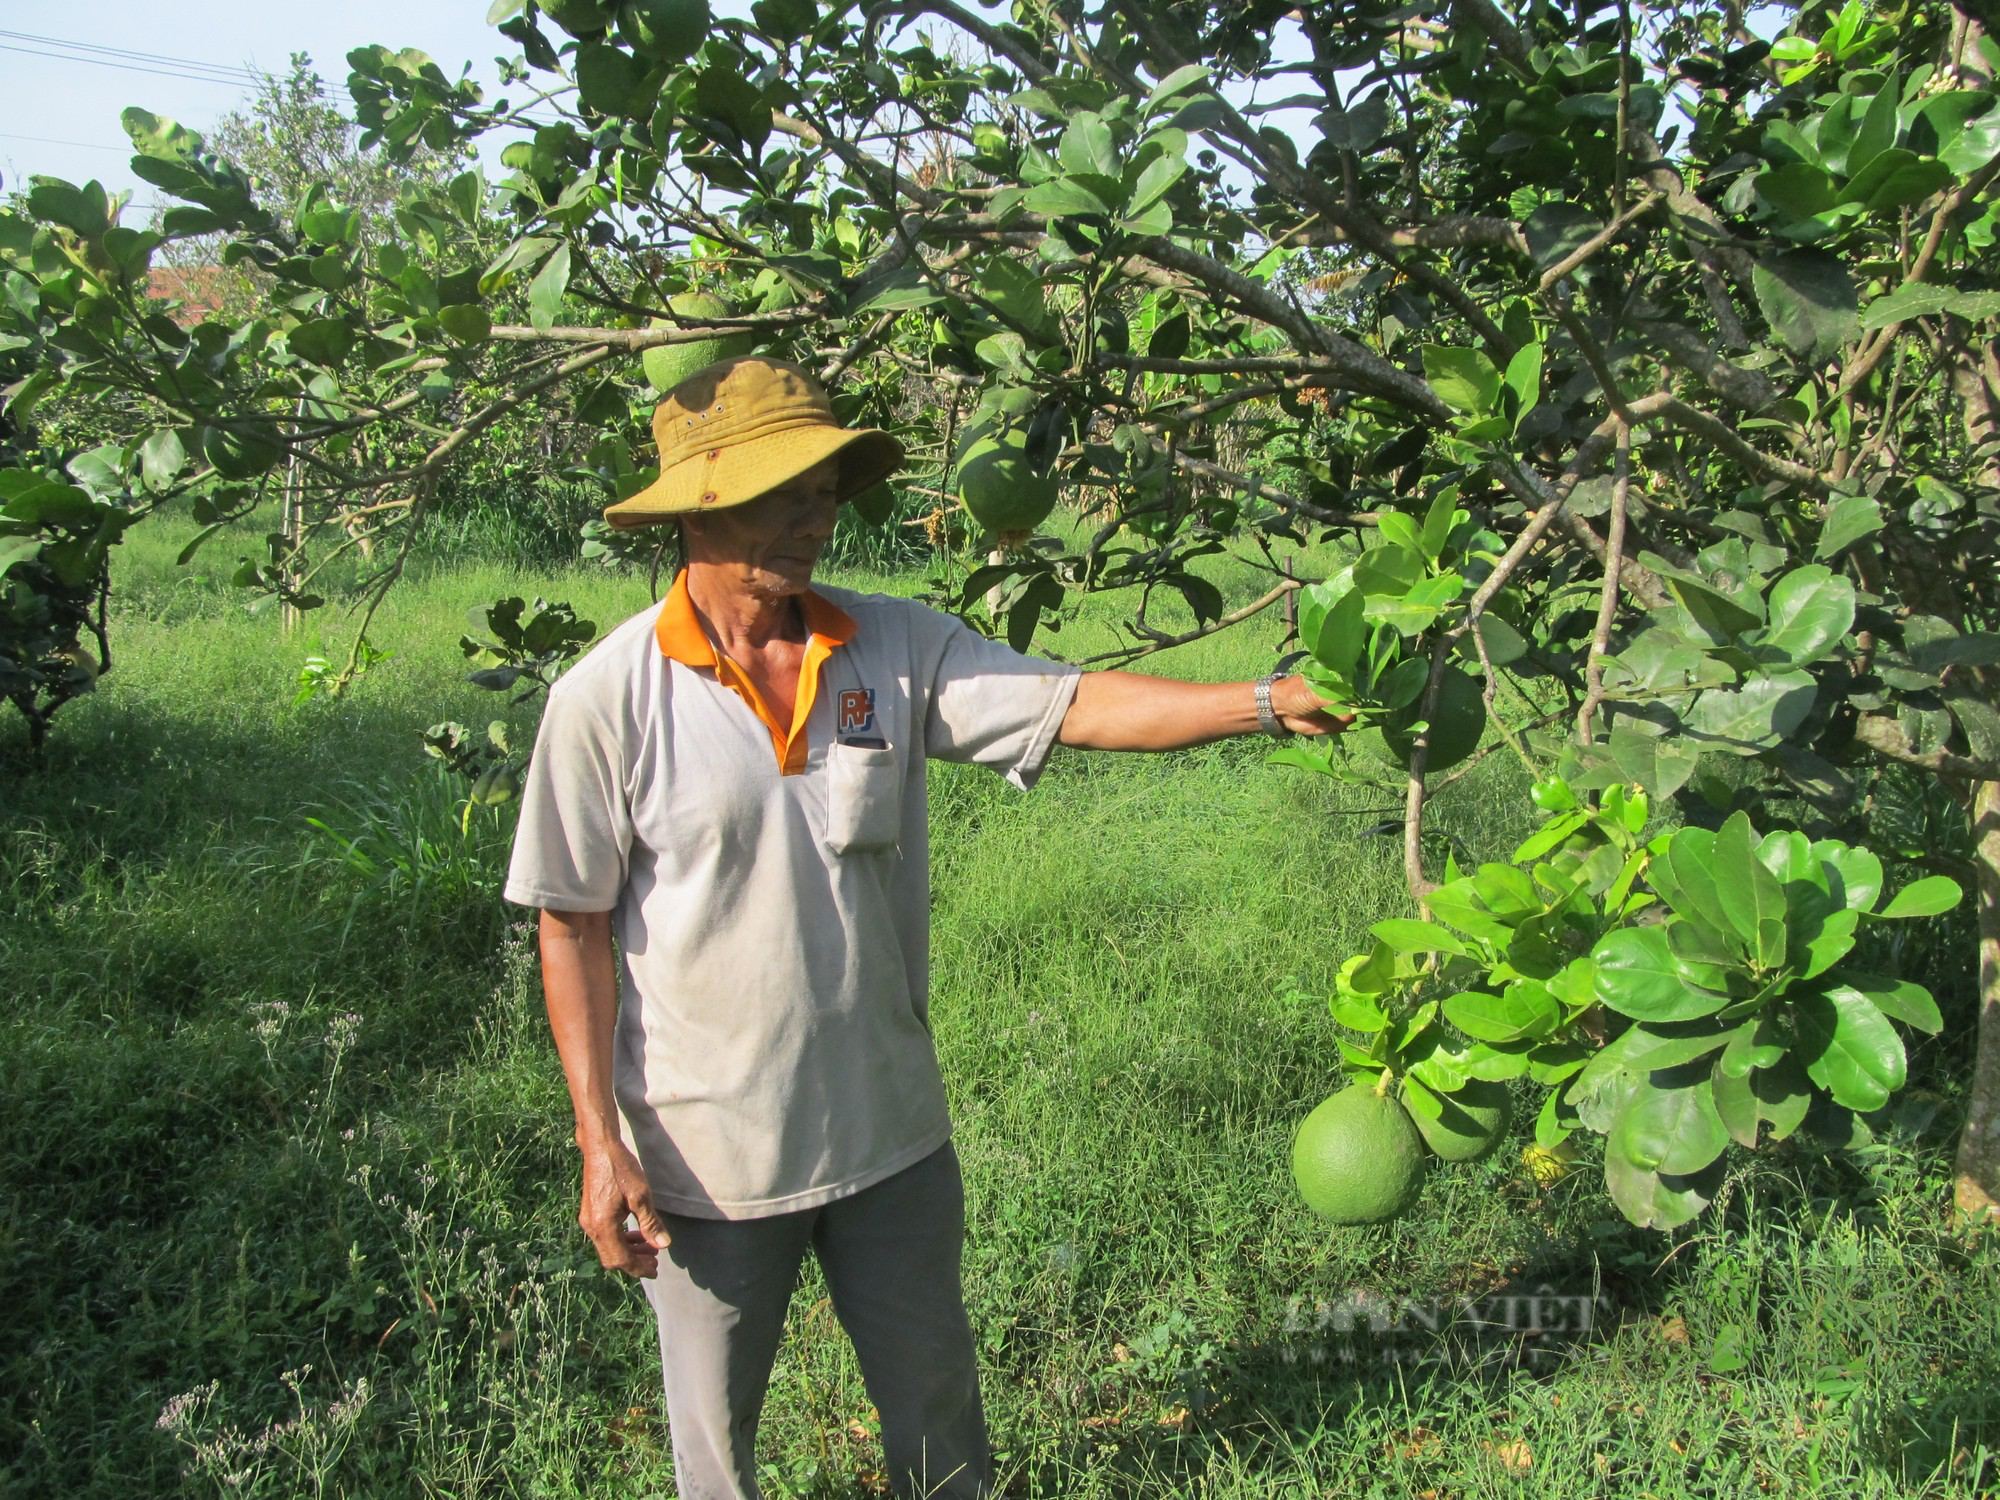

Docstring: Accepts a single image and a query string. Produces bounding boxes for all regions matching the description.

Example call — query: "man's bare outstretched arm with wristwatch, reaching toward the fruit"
[1056,672,1352,750]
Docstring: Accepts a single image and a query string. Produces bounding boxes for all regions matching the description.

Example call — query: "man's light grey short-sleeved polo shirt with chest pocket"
[506,588,1078,1218]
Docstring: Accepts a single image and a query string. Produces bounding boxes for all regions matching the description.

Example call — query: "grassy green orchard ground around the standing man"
[0,508,2000,1496]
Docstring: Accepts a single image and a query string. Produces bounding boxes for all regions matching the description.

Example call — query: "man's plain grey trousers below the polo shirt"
[640,1142,992,1500]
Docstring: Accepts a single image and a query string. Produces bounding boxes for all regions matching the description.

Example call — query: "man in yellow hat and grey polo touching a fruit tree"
[506,358,1344,1500]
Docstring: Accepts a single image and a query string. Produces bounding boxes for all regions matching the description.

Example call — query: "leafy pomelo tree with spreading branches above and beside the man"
[0,0,2000,1226]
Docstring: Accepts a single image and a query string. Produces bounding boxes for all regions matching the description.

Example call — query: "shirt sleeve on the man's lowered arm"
[506,684,632,912]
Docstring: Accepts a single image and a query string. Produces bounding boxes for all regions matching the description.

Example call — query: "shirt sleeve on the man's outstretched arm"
[924,610,1080,788]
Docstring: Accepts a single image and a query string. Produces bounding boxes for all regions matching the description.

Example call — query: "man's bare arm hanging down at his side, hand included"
[540,908,668,1276]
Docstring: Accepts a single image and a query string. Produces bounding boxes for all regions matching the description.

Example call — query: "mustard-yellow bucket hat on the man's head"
[604,356,902,530]
